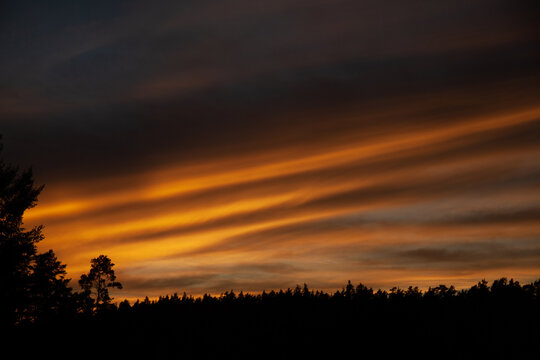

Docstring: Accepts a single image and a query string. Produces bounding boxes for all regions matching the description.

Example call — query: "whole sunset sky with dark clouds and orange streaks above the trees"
[0,0,540,299]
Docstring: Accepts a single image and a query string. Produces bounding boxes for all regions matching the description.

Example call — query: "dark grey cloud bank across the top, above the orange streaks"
[0,1,540,186]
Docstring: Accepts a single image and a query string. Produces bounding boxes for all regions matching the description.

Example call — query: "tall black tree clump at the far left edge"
[0,139,73,326]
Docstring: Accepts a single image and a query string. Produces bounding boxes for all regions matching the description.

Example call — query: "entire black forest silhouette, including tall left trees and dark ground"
[0,139,540,359]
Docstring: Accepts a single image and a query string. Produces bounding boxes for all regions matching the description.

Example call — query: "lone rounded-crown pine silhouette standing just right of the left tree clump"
[79,255,122,308]
